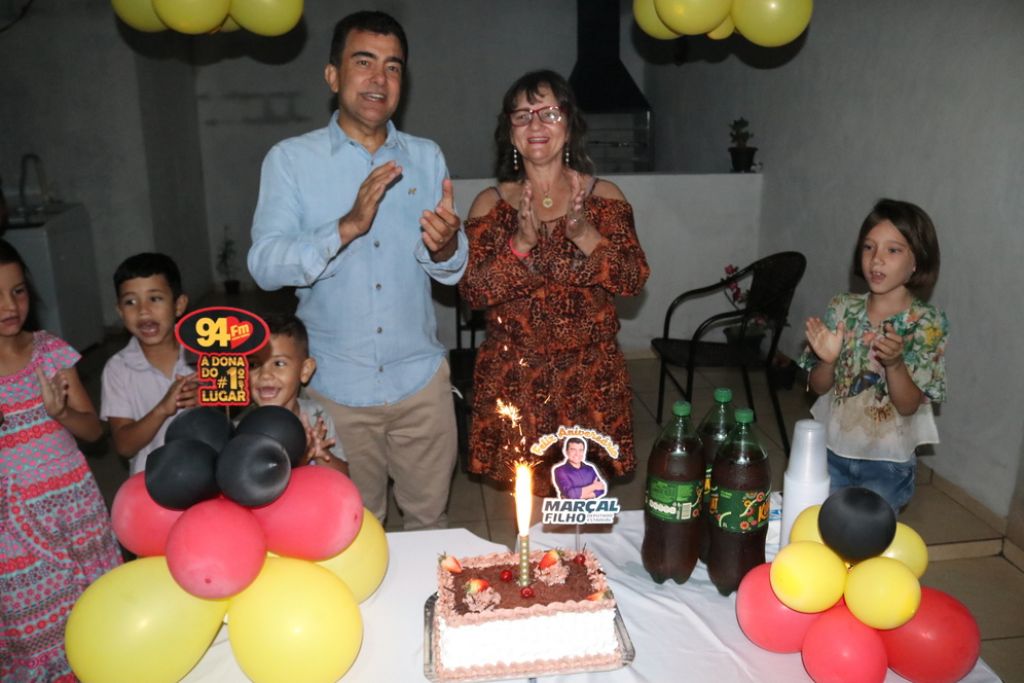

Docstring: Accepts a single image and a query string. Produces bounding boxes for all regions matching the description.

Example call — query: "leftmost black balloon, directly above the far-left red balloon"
[145,438,220,510]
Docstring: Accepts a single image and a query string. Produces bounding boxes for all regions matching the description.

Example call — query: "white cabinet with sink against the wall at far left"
[3,204,103,350]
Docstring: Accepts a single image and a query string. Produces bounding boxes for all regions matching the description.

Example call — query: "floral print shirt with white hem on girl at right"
[797,294,949,462]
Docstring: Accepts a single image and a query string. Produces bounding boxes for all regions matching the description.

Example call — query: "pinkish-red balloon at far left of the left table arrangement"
[111,472,181,557]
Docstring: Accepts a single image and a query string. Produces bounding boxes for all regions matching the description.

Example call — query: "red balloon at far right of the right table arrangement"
[881,586,981,683]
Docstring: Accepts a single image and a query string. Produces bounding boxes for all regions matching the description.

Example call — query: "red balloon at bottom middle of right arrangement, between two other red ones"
[802,604,888,683]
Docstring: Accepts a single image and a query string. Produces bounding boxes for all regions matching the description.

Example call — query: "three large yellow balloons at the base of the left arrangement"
[66,510,388,683]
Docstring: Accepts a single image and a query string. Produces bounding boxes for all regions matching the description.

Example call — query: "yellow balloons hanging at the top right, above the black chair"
[633,0,814,47]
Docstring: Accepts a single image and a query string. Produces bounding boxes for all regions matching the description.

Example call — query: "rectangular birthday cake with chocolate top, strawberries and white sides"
[432,550,623,681]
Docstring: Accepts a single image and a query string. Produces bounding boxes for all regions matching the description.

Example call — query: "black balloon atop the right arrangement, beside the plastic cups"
[818,486,896,562]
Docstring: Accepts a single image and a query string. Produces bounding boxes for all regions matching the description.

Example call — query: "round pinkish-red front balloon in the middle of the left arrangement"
[167,499,266,599]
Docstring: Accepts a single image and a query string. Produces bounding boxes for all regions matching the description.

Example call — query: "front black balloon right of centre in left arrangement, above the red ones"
[217,434,292,508]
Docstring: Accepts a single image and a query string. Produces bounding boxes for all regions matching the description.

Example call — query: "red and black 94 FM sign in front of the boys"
[174,307,270,405]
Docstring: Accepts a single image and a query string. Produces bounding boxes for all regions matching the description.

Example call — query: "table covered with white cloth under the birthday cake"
[184,511,999,683]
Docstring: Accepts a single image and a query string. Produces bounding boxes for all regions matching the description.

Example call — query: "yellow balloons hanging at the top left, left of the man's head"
[111,0,302,36]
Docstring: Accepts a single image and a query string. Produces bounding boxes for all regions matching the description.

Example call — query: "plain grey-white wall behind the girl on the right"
[641,0,1024,515]
